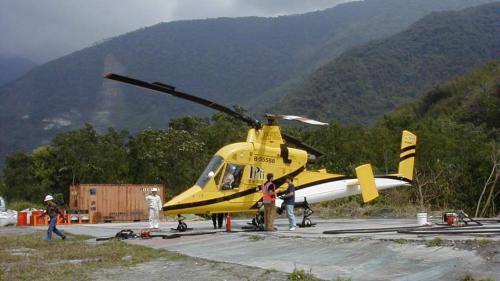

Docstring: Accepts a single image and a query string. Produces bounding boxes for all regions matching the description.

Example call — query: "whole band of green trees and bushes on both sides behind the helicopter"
[0,61,500,215]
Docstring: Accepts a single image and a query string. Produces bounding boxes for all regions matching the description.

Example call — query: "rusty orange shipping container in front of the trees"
[69,184,165,223]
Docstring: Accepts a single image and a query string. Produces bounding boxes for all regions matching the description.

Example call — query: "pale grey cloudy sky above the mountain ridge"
[0,0,352,63]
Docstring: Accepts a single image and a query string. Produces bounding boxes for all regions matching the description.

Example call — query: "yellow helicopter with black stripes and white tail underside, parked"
[105,73,417,231]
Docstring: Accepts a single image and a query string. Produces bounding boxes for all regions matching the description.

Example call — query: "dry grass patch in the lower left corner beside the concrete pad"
[0,232,183,280]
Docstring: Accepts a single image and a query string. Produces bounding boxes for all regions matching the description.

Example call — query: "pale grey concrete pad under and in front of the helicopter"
[21,219,500,280]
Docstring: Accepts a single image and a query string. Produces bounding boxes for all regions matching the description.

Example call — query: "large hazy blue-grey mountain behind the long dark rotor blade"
[0,0,490,165]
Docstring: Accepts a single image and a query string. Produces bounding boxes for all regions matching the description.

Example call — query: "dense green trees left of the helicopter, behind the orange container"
[0,114,244,202]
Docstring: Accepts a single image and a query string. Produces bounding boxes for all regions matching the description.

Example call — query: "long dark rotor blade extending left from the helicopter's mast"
[104,73,261,128]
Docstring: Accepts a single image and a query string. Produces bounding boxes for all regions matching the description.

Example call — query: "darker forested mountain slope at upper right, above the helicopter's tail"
[280,2,500,123]
